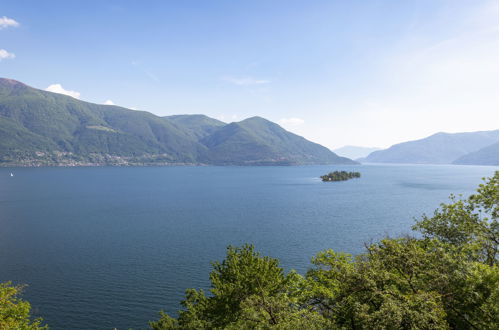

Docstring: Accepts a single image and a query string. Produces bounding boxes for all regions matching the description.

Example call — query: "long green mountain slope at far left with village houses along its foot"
[0,79,206,165]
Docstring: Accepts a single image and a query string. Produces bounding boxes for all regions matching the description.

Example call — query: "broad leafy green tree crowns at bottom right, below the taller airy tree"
[307,238,499,329]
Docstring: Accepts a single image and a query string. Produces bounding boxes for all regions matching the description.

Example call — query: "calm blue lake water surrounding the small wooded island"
[0,165,499,329]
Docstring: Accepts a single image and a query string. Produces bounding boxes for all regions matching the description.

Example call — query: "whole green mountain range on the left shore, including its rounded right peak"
[0,78,352,166]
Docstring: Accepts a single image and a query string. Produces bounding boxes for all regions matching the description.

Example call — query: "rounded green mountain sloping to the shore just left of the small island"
[200,117,355,165]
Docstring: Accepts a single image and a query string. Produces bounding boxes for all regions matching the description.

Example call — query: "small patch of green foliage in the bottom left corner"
[0,282,48,330]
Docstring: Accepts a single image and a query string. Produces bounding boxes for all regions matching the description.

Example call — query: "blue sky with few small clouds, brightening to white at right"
[0,0,499,149]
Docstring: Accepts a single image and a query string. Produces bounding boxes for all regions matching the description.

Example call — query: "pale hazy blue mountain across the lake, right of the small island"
[360,130,499,164]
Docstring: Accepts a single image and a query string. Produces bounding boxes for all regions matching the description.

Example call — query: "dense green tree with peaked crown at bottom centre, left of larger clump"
[150,245,327,329]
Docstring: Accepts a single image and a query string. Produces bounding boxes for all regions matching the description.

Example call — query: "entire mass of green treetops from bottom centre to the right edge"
[150,172,499,329]
